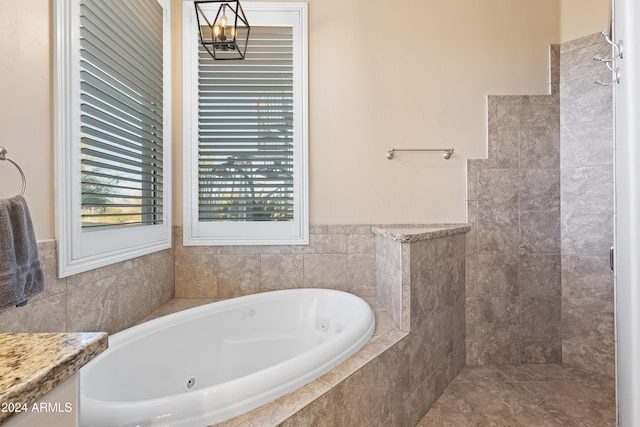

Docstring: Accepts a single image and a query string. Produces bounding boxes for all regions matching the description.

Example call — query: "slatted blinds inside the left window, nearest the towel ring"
[80,0,163,230]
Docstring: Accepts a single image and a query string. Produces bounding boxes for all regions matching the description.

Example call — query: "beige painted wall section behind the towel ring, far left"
[0,0,54,239]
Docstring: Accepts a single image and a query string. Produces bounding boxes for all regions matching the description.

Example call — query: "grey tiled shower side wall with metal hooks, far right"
[560,34,615,378]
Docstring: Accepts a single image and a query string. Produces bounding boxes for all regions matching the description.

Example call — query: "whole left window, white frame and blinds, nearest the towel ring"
[53,0,171,277]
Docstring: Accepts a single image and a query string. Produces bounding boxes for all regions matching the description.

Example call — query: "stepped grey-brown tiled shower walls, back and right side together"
[466,35,614,377]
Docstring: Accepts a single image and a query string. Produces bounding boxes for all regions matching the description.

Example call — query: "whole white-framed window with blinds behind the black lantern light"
[183,2,309,245]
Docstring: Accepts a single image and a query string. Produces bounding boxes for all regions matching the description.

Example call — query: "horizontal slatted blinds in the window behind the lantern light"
[198,27,294,222]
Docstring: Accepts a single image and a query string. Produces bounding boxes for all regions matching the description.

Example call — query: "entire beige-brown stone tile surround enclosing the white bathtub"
[0,224,468,427]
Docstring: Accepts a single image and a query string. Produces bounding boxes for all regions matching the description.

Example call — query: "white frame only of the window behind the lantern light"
[182,1,309,246]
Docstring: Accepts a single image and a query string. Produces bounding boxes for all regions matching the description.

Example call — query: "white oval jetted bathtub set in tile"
[80,289,375,427]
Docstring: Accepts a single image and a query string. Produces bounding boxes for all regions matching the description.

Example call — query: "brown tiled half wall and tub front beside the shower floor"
[282,226,467,427]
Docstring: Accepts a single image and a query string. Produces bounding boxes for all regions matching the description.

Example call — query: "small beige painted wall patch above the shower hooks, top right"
[560,0,610,43]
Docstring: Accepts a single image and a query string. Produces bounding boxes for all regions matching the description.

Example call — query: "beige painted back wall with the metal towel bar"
[174,0,559,224]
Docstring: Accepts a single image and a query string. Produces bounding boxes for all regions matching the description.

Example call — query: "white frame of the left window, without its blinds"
[54,0,172,277]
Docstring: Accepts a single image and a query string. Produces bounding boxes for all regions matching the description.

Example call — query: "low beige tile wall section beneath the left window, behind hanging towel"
[0,240,175,333]
